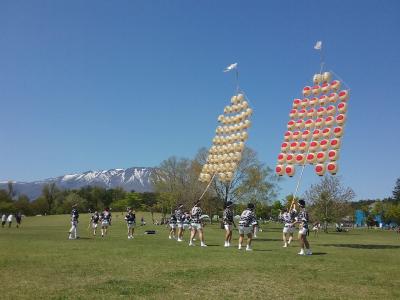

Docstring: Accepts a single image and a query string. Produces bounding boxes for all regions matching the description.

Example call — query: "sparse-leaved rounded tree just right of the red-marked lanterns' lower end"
[305,176,355,232]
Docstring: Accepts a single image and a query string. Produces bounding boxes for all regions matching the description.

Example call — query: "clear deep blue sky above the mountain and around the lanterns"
[0,0,400,199]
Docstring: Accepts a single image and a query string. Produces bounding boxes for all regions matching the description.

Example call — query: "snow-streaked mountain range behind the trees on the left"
[0,167,153,200]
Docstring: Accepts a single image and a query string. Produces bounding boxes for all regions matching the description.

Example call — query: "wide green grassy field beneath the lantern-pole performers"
[0,213,400,299]
